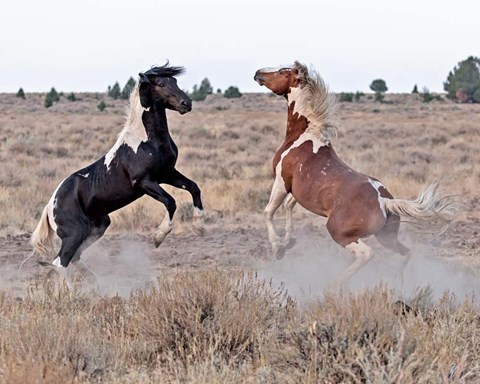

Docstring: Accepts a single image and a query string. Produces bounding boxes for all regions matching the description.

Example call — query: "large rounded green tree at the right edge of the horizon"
[443,56,480,103]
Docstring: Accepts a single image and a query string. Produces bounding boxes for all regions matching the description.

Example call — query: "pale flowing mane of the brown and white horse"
[289,61,337,140]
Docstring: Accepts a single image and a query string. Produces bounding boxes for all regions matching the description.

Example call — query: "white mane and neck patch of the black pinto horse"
[105,84,148,168]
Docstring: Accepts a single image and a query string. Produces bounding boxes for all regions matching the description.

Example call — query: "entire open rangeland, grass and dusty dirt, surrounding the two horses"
[0,89,480,383]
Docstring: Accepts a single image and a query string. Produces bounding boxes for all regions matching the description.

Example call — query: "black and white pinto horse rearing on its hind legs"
[31,63,204,280]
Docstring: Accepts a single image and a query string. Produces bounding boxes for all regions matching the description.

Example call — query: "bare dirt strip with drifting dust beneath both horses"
[0,207,480,300]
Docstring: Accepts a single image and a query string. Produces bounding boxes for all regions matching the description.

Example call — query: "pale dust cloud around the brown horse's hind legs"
[255,228,480,304]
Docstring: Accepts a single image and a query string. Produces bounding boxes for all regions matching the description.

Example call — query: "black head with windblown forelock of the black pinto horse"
[139,63,192,115]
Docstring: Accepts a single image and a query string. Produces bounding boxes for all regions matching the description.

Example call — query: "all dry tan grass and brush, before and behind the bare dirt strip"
[0,90,480,383]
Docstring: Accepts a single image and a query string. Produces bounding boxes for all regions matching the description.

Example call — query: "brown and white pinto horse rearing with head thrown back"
[254,62,454,283]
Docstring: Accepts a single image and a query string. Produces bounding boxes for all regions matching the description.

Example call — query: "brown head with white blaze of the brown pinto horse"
[253,62,308,95]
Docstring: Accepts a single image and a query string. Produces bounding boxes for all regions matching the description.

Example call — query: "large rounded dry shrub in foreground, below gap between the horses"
[129,271,285,365]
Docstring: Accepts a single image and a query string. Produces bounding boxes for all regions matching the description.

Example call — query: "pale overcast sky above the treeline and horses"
[0,0,480,92]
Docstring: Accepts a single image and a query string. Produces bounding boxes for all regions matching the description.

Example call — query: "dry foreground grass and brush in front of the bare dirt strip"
[0,270,480,383]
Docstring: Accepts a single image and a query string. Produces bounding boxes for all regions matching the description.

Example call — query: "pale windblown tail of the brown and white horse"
[384,182,458,234]
